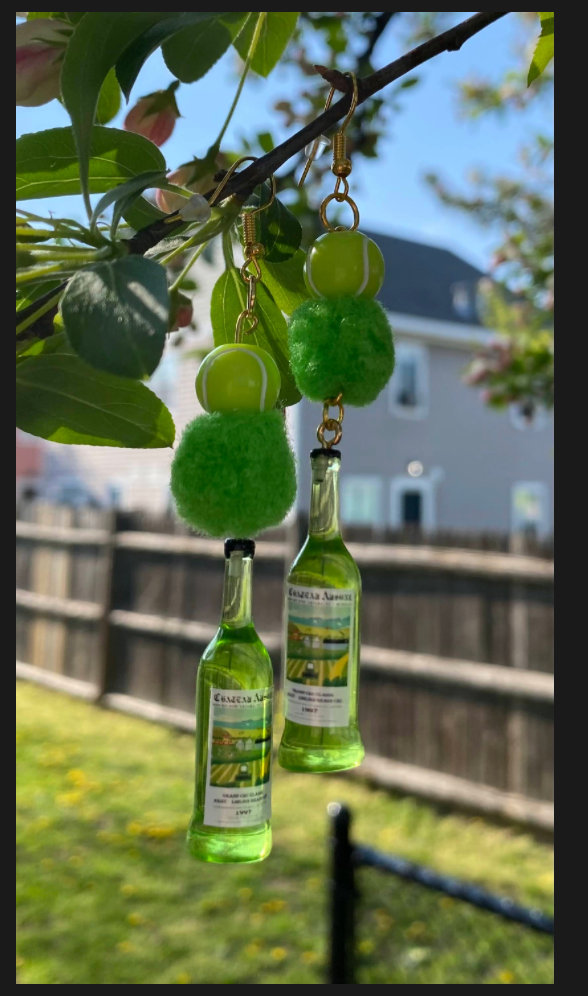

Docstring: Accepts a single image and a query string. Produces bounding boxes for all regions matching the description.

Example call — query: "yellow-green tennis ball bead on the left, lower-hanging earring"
[196,342,281,412]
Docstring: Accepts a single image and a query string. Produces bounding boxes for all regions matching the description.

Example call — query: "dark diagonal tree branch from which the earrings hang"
[17,10,510,338]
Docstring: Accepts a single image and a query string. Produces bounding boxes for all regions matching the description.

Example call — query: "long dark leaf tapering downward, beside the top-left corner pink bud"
[61,11,175,210]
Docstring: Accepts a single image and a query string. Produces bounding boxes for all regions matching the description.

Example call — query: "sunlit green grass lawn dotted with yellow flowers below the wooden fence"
[17,684,553,985]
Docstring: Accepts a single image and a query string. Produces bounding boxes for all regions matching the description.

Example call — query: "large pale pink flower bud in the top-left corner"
[16,18,65,107]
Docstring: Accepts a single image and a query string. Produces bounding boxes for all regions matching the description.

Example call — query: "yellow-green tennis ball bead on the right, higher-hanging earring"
[304,232,385,298]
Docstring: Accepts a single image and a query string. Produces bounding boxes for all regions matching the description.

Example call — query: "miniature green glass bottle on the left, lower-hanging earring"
[188,540,273,864]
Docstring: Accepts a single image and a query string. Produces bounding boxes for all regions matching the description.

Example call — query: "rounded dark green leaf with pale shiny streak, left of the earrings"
[61,256,169,379]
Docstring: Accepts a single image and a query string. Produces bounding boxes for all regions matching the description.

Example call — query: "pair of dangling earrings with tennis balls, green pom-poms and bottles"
[172,74,394,863]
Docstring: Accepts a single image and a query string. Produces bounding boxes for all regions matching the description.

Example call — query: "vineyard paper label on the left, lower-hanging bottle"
[204,688,274,829]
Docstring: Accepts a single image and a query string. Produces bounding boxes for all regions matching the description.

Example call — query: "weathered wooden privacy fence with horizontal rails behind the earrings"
[16,505,554,830]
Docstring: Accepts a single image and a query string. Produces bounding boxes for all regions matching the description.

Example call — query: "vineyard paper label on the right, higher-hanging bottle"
[285,584,357,728]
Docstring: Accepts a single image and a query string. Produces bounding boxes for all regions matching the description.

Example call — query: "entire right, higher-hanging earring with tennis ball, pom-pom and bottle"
[279,73,394,772]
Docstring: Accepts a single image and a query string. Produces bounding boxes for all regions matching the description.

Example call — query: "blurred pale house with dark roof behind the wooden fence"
[17,234,554,536]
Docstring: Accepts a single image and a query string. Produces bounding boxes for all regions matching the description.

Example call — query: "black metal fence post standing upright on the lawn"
[328,803,356,985]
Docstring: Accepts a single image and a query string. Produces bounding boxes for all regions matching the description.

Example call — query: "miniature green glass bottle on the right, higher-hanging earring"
[279,449,365,772]
